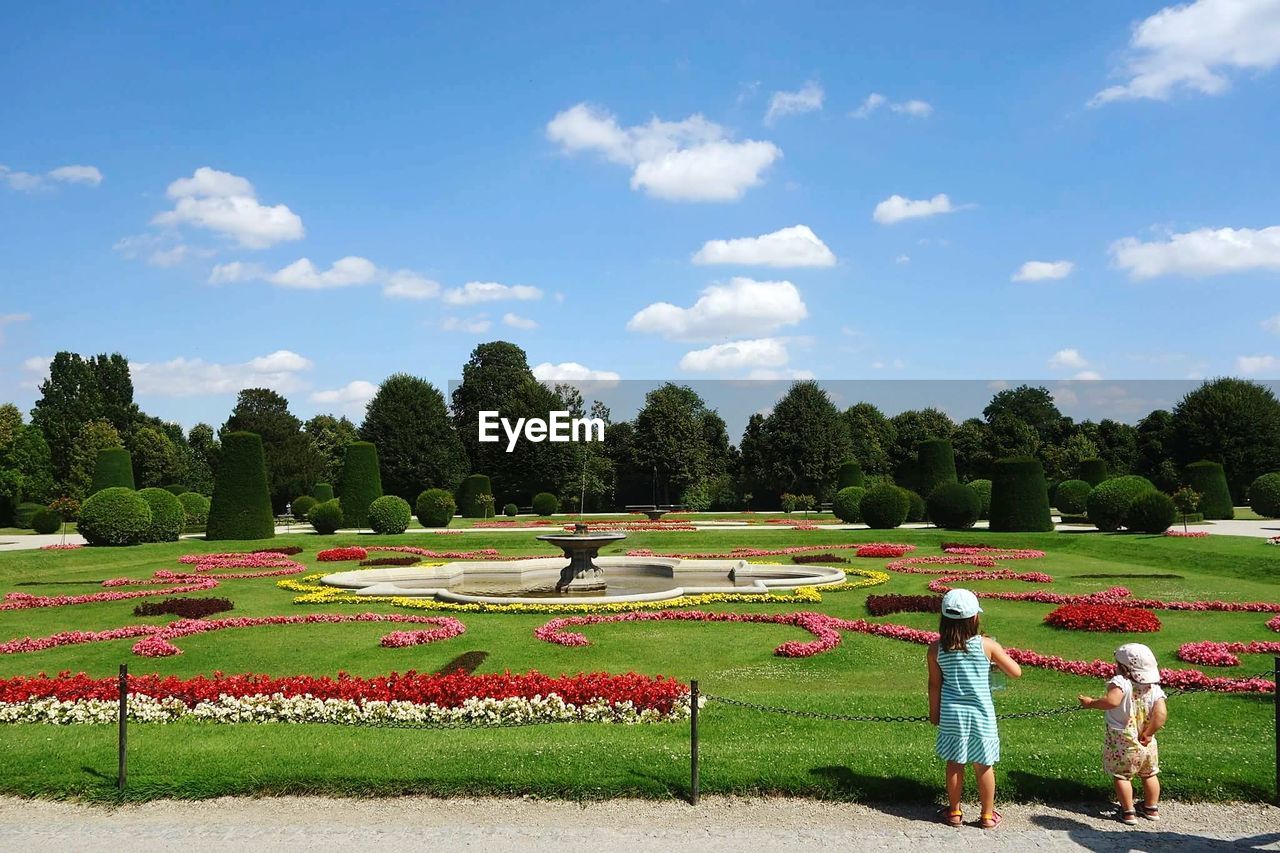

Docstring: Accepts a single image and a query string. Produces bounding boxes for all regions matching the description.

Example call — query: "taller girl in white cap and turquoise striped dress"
[928,589,1023,829]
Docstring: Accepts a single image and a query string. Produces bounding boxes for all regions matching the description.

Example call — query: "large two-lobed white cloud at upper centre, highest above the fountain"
[547,104,782,201]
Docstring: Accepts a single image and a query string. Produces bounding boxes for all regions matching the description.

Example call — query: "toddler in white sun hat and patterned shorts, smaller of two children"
[1080,643,1169,826]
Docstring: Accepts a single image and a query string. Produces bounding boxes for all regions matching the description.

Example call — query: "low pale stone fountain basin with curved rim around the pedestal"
[321,557,845,605]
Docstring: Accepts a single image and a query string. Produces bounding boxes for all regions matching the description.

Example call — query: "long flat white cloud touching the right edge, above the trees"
[1111,225,1280,279]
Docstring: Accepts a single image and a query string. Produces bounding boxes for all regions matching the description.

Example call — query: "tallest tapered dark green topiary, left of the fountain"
[205,432,275,539]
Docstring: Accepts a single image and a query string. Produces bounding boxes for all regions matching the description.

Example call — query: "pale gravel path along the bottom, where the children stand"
[0,797,1280,853]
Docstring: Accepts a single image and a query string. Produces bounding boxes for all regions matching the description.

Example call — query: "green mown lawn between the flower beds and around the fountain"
[0,529,1280,800]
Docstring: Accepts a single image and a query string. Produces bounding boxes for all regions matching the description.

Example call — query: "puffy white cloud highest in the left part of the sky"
[151,167,306,248]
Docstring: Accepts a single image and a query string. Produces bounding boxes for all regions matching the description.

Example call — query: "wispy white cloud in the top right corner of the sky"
[1089,0,1280,106]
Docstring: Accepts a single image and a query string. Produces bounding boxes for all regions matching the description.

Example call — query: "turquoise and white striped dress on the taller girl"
[937,634,1000,766]
